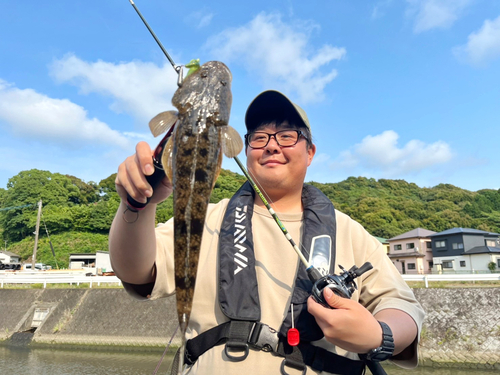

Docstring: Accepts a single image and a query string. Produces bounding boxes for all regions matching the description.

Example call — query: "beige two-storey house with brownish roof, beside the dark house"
[387,228,436,274]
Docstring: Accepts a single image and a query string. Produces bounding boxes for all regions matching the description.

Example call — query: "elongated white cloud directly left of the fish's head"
[50,54,177,121]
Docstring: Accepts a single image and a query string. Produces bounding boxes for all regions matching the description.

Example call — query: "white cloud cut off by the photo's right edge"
[453,16,500,65]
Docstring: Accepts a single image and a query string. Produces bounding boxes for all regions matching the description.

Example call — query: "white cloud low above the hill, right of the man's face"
[331,130,453,177]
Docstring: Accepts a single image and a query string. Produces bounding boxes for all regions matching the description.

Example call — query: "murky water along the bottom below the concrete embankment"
[0,346,498,375]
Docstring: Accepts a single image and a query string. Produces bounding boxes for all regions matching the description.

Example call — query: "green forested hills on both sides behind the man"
[0,169,500,267]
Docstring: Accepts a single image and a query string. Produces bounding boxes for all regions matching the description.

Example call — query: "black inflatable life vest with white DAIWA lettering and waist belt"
[184,182,365,375]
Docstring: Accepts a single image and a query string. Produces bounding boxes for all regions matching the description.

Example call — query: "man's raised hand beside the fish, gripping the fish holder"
[115,142,173,207]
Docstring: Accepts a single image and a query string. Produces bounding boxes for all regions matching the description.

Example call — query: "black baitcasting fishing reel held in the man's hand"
[308,262,373,309]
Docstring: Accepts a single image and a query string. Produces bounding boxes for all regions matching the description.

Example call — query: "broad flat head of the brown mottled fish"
[172,61,233,126]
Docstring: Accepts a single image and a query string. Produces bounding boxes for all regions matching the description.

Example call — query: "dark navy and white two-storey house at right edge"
[430,228,500,273]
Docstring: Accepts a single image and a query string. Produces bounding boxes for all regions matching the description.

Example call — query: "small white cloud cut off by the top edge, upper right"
[406,0,474,33]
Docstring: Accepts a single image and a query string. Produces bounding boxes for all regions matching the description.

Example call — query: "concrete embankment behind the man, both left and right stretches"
[0,288,500,370]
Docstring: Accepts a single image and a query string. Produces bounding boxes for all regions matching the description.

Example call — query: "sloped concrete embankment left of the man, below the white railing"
[0,289,177,348]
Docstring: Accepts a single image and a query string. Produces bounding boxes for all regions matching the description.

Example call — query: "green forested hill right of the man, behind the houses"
[312,177,500,238]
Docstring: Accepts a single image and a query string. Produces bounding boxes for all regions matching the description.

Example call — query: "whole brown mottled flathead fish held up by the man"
[149,61,243,336]
